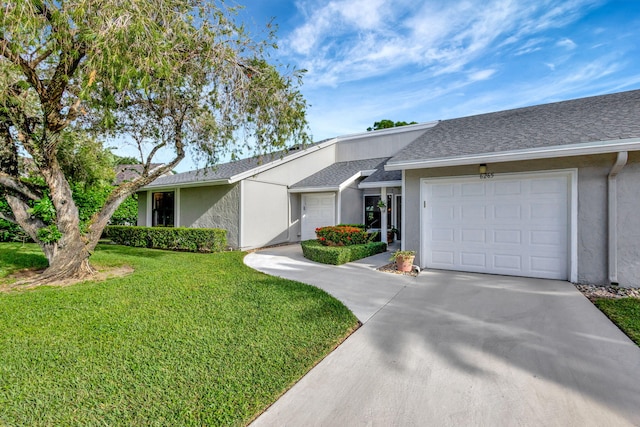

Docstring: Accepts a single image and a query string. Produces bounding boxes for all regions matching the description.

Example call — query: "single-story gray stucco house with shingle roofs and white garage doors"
[139,90,640,286]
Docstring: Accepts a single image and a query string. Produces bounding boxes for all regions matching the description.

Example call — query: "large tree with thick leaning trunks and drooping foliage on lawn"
[0,0,307,283]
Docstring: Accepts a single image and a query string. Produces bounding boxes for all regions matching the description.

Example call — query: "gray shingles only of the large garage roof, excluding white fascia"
[390,90,640,163]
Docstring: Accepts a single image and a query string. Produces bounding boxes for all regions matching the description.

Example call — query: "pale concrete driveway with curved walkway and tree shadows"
[245,245,640,426]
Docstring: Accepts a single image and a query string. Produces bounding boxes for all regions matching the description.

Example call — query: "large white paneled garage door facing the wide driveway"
[422,174,570,280]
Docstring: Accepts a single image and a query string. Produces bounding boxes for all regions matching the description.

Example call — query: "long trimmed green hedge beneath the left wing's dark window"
[104,225,227,252]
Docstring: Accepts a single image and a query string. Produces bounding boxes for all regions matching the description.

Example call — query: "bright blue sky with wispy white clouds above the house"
[172,0,640,171]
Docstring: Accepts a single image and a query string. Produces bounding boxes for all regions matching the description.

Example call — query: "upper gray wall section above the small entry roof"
[336,129,425,162]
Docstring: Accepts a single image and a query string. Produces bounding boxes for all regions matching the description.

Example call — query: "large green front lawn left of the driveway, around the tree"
[0,244,357,426]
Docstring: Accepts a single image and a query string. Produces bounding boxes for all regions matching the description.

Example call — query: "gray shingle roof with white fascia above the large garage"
[387,90,640,170]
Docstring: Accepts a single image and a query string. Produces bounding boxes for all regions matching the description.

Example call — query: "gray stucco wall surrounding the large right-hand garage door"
[403,153,640,286]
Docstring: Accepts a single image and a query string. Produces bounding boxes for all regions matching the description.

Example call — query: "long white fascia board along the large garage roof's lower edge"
[384,138,640,171]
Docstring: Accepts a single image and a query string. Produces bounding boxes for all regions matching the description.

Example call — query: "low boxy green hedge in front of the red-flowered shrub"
[300,240,387,265]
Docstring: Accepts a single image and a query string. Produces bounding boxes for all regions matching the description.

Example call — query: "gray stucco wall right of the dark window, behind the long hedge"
[180,184,240,248]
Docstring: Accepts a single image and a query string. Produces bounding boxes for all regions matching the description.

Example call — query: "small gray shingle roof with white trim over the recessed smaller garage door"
[289,157,389,193]
